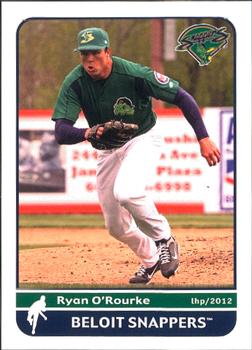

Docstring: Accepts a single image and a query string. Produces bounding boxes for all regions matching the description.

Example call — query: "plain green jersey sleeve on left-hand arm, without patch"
[52,83,81,123]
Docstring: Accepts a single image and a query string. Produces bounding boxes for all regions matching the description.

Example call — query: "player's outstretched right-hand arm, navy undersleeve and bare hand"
[173,87,220,166]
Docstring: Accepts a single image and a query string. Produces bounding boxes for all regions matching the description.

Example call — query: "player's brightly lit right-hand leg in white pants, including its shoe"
[114,128,179,277]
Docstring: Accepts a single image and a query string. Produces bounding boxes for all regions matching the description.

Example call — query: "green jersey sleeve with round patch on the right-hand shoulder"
[136,67,179,103]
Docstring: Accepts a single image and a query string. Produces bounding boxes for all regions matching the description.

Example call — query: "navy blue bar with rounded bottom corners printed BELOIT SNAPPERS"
[17,310,236,336]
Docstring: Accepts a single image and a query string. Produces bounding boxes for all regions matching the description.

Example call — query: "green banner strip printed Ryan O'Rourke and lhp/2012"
[16,292,237,308]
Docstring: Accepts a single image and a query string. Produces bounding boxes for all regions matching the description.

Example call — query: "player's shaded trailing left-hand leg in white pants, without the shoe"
[97,151,159,273]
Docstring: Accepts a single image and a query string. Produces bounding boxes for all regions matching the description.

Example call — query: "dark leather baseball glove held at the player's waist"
[87,120,138,150]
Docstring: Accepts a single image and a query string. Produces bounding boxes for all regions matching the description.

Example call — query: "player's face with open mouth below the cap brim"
[80,49,112,80]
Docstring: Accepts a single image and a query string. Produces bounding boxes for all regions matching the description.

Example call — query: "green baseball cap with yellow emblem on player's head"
[74,28,110,51]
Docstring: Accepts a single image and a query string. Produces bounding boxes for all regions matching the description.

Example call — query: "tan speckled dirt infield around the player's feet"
[19,228,234,288]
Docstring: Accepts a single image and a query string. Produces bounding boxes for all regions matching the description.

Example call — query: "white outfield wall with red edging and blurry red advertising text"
[17,108,234,213]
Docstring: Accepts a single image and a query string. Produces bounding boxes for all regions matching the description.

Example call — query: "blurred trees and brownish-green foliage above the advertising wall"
[18,18,234,109]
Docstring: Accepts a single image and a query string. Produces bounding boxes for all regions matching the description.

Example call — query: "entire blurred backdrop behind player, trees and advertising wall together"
[17,18,235,214]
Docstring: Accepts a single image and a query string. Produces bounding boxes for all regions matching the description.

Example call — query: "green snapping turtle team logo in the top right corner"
[175,23,230,66]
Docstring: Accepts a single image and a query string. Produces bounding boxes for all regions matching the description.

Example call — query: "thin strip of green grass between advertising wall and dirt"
[19,214,234,228]
